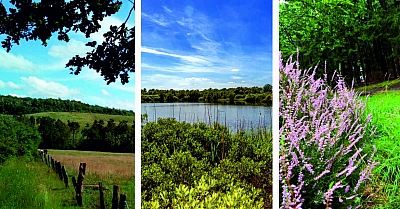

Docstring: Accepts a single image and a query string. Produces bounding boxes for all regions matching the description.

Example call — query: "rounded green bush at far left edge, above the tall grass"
[0,115,42,163]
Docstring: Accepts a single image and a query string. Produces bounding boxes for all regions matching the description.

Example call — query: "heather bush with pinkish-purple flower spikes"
[279,51,378,208]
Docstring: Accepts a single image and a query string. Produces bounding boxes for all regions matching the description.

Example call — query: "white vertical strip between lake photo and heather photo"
[272,0,280,209]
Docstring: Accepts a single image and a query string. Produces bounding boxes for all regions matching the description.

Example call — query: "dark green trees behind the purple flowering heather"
[279,0,400,84]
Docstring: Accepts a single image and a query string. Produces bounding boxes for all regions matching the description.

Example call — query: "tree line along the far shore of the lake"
[141,84,272,105]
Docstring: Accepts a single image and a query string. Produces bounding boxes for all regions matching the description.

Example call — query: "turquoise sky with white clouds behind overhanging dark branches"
[0,0,135,110]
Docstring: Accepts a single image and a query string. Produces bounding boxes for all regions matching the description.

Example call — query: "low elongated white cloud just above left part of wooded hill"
[21,76,80,99]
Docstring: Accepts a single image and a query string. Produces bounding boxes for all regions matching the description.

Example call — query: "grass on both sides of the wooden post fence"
[0,150,135,209]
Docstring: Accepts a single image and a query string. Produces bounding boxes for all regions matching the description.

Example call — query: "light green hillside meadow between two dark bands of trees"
[27,112,135,128]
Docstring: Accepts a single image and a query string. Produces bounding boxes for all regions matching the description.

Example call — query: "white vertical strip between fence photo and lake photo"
[134,0,142,208]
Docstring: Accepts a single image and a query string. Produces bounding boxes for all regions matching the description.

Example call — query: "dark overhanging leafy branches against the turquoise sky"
[0,0,135,84]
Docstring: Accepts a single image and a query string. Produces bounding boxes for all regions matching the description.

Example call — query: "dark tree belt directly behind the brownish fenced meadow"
[14,116,135,153]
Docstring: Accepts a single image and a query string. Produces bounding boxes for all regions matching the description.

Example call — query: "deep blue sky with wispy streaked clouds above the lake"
[141,0,272,89]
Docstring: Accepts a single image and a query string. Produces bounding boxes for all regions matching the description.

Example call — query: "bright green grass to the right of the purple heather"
[364,91,400,208]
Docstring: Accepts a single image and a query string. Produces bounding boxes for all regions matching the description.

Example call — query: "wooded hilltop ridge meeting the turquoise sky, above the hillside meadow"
[0,95,135,116]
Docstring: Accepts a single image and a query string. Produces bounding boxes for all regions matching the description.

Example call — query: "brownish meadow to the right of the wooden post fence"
[48,150,135,206]
